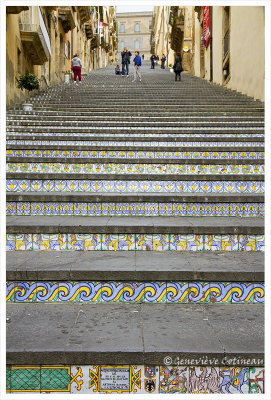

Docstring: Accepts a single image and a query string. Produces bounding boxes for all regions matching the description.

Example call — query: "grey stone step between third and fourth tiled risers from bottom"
[6,216,264,235]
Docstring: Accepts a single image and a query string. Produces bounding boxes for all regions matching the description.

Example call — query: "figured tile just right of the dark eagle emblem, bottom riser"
[159,366,189,394]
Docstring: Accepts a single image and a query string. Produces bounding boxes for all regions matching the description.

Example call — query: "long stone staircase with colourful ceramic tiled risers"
[7,63,264,394]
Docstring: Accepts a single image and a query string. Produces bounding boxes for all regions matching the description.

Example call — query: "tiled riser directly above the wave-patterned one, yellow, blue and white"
[6,233,264,251]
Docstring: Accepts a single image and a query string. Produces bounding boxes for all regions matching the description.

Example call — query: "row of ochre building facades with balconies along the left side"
[6,6,117,107]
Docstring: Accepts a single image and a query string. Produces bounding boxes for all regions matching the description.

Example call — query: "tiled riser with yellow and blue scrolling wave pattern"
[6,282,264,304]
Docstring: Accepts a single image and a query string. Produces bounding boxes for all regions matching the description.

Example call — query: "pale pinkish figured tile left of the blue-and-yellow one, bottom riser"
[188,367,220,394]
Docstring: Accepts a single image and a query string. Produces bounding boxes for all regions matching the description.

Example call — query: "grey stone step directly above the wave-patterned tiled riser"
[6,250,264,282]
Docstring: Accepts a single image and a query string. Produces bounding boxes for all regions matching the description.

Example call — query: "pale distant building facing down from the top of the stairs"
[116,12,153,61]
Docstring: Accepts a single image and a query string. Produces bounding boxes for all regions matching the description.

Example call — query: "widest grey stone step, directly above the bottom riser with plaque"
[7,302,264,366]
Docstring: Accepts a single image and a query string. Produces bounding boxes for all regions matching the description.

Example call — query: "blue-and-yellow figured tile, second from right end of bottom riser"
[219,367,249,394]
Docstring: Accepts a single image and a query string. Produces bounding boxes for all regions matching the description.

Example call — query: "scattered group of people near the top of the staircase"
[71,47,183,84]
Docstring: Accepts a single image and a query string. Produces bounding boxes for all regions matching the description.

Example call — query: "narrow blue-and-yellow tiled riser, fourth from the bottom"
[6,202,264,217]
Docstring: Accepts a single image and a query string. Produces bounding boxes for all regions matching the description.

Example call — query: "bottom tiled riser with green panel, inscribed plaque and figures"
[6,366,265,394]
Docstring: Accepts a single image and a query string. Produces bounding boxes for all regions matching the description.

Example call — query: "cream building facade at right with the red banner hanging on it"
[193,6,265,100]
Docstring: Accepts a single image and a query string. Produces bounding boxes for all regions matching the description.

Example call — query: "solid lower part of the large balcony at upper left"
[19,24,51,65]
